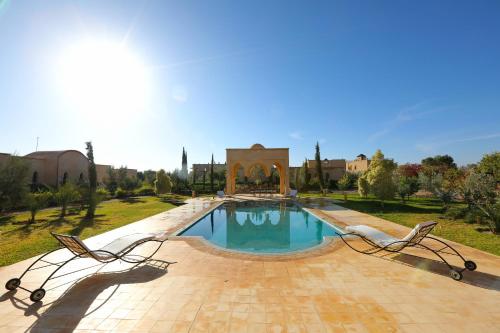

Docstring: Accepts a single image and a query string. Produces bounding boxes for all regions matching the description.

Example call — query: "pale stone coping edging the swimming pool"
[168,199,344,261]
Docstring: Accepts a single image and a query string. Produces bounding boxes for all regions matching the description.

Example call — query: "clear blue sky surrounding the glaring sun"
[0,0,500,169]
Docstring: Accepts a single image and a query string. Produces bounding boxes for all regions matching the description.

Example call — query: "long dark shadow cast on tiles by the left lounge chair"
[0,260,170,332]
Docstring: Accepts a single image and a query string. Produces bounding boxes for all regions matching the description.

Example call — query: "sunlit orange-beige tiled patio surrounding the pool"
[0,196,500,333]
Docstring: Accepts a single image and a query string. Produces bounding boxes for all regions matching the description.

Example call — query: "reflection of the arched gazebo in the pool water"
[226,200,290,249]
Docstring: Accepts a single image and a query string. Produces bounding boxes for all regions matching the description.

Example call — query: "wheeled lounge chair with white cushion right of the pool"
[337,221,477,281]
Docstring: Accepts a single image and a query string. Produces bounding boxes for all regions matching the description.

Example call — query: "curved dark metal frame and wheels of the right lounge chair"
[336,230,477,281]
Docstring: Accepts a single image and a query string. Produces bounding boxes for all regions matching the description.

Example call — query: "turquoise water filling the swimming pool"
[179,201,342,253]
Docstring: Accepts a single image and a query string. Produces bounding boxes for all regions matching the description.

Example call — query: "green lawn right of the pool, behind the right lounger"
[301,193,500,255]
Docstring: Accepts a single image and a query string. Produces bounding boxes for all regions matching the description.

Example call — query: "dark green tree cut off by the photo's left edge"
[0,156,30,210]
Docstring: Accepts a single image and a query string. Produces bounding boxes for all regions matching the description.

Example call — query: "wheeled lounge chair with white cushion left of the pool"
[5,233,167,302]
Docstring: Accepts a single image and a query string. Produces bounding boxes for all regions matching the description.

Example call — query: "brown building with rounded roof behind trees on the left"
[0,150,137,187]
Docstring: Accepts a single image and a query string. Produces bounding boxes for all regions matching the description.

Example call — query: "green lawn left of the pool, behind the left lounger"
[0,197,185,266]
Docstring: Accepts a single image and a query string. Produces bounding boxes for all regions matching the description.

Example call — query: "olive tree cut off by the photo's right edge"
[464,172,500,233]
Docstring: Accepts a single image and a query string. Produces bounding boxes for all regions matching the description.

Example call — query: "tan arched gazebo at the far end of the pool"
[226,143,290,194]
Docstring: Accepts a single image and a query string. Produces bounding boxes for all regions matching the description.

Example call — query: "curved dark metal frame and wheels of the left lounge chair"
[5,233,168,302]
